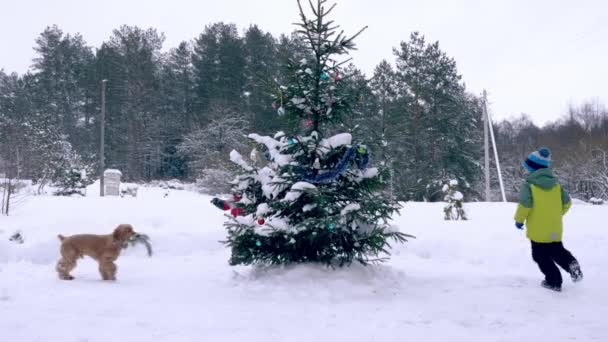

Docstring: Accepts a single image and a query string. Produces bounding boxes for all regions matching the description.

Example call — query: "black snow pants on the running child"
[532,241,576,287]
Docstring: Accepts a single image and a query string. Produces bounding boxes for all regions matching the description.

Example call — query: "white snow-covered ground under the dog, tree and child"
[0,188,608,342]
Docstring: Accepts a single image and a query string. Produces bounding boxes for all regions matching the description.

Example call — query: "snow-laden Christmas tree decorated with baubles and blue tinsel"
[214,0,409,266]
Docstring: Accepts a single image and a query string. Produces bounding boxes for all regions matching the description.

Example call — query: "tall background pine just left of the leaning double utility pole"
[395,33,482,200]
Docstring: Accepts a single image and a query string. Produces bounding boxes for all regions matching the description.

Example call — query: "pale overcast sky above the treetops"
[0,0,608,124]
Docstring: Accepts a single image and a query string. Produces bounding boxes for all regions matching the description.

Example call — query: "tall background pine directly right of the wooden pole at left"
[97,25,165,179]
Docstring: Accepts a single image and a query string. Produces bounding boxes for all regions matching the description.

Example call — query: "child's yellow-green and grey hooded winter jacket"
[515,169,572,243]
